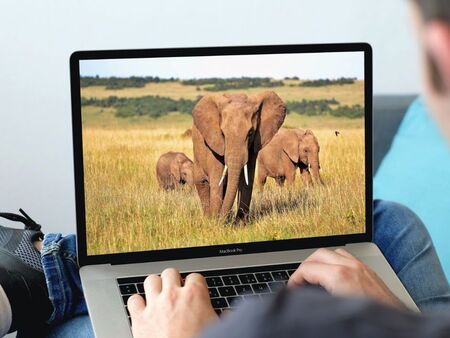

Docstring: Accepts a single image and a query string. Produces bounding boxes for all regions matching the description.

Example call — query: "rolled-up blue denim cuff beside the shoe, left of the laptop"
[41,234,87,324]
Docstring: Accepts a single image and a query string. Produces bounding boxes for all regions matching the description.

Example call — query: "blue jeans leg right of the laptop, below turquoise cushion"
[374,200,450,312]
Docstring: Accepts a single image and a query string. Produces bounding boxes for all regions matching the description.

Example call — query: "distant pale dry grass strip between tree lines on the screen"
[81,80,364,106]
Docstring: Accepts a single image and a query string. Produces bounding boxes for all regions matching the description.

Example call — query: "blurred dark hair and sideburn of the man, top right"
[413,0,450,91]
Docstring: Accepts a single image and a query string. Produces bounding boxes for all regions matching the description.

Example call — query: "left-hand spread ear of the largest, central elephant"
[192,95,228,156]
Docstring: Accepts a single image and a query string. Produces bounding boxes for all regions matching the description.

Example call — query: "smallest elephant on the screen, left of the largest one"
[156,151,194,190]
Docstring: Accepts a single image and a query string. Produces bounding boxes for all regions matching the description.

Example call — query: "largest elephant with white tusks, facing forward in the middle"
[192,91,286,220]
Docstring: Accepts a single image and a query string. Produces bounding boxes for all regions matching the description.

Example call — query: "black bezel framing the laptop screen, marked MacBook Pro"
[70,43,373,266]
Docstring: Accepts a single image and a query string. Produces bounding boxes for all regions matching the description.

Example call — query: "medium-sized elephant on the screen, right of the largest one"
[258,128,323,191]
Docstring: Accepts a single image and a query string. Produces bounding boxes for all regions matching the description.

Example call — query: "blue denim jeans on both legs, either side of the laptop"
[42,200,450,338]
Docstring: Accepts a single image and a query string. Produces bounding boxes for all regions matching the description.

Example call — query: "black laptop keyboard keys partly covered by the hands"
[117,263,299,322]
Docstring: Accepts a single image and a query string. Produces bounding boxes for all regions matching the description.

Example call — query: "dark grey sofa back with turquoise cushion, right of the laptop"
[373,96,450,279]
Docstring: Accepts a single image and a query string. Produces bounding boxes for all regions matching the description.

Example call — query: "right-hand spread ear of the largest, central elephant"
[253,91,286,153]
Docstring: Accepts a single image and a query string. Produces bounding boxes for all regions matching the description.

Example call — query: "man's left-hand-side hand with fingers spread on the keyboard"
[128,269,218,338]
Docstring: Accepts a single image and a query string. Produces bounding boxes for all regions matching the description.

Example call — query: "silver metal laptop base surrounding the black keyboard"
[80,243,419,337]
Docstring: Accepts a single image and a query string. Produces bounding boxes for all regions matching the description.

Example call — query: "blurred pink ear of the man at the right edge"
[425,21,450,91]
